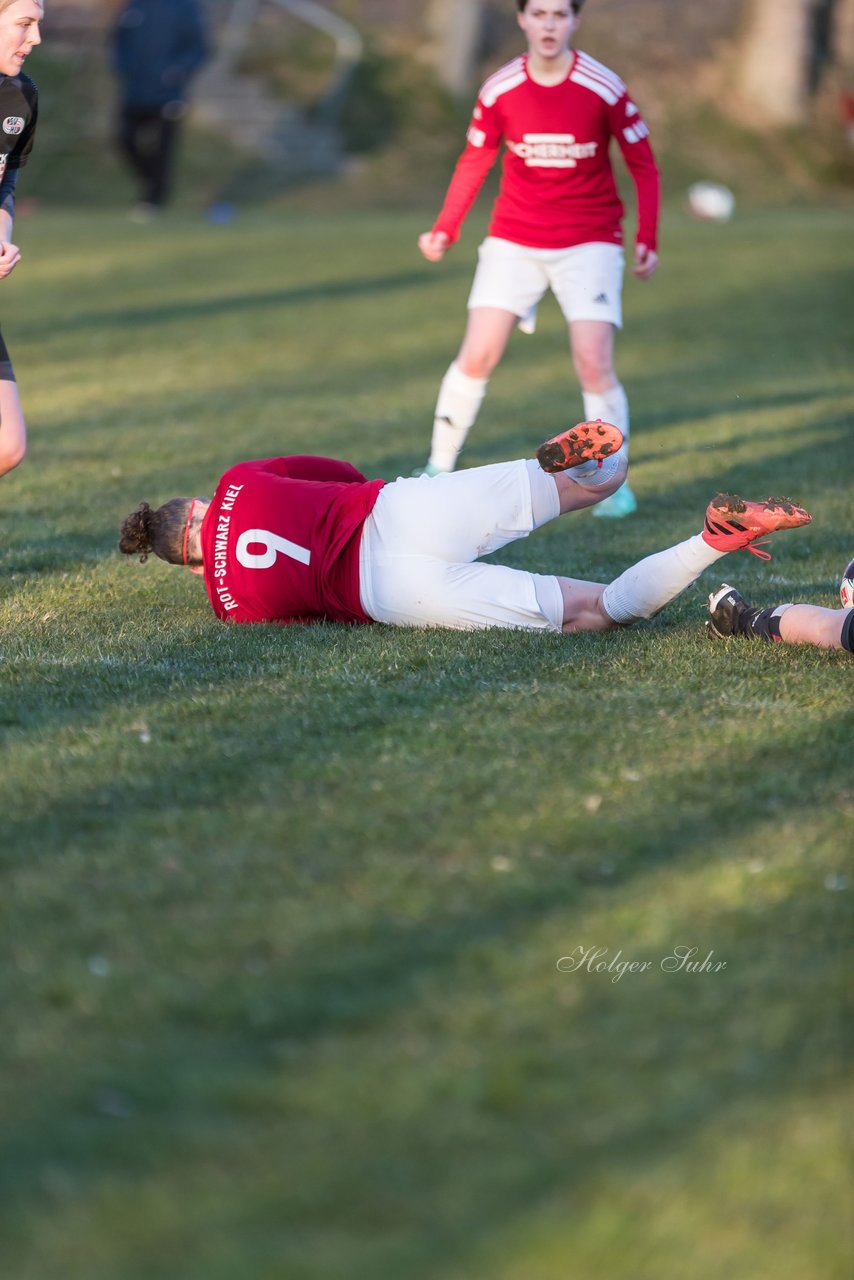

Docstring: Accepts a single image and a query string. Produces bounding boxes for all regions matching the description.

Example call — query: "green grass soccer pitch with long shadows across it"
[0,207,854,1280]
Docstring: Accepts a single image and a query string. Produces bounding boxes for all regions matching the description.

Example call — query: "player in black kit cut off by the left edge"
[0,0,44,475]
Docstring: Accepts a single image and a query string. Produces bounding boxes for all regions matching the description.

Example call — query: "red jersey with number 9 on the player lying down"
[201,457,385,622]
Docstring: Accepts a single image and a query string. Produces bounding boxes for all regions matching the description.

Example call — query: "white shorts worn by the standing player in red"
[469,236,625,332]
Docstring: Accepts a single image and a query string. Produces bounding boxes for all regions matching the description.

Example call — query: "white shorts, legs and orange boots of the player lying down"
[360,440,810,632]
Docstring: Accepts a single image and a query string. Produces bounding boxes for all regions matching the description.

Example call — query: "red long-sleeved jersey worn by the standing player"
[433,51,659,248]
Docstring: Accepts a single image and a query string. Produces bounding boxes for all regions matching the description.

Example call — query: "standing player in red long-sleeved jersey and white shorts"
[419,0,659,516]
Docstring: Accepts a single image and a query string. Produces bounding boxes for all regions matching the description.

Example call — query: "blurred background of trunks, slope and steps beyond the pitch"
[22,0,854,211]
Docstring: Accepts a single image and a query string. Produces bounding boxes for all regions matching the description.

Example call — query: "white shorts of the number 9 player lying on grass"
[360,460,563,631]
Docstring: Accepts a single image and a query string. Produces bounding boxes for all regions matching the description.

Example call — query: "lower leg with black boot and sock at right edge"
[705,582,854,653]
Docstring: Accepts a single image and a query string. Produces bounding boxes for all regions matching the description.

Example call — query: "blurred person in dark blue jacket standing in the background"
[113,0,207,221]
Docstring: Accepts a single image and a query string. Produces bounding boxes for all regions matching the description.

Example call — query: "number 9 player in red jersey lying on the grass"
[119,422,810,631]
